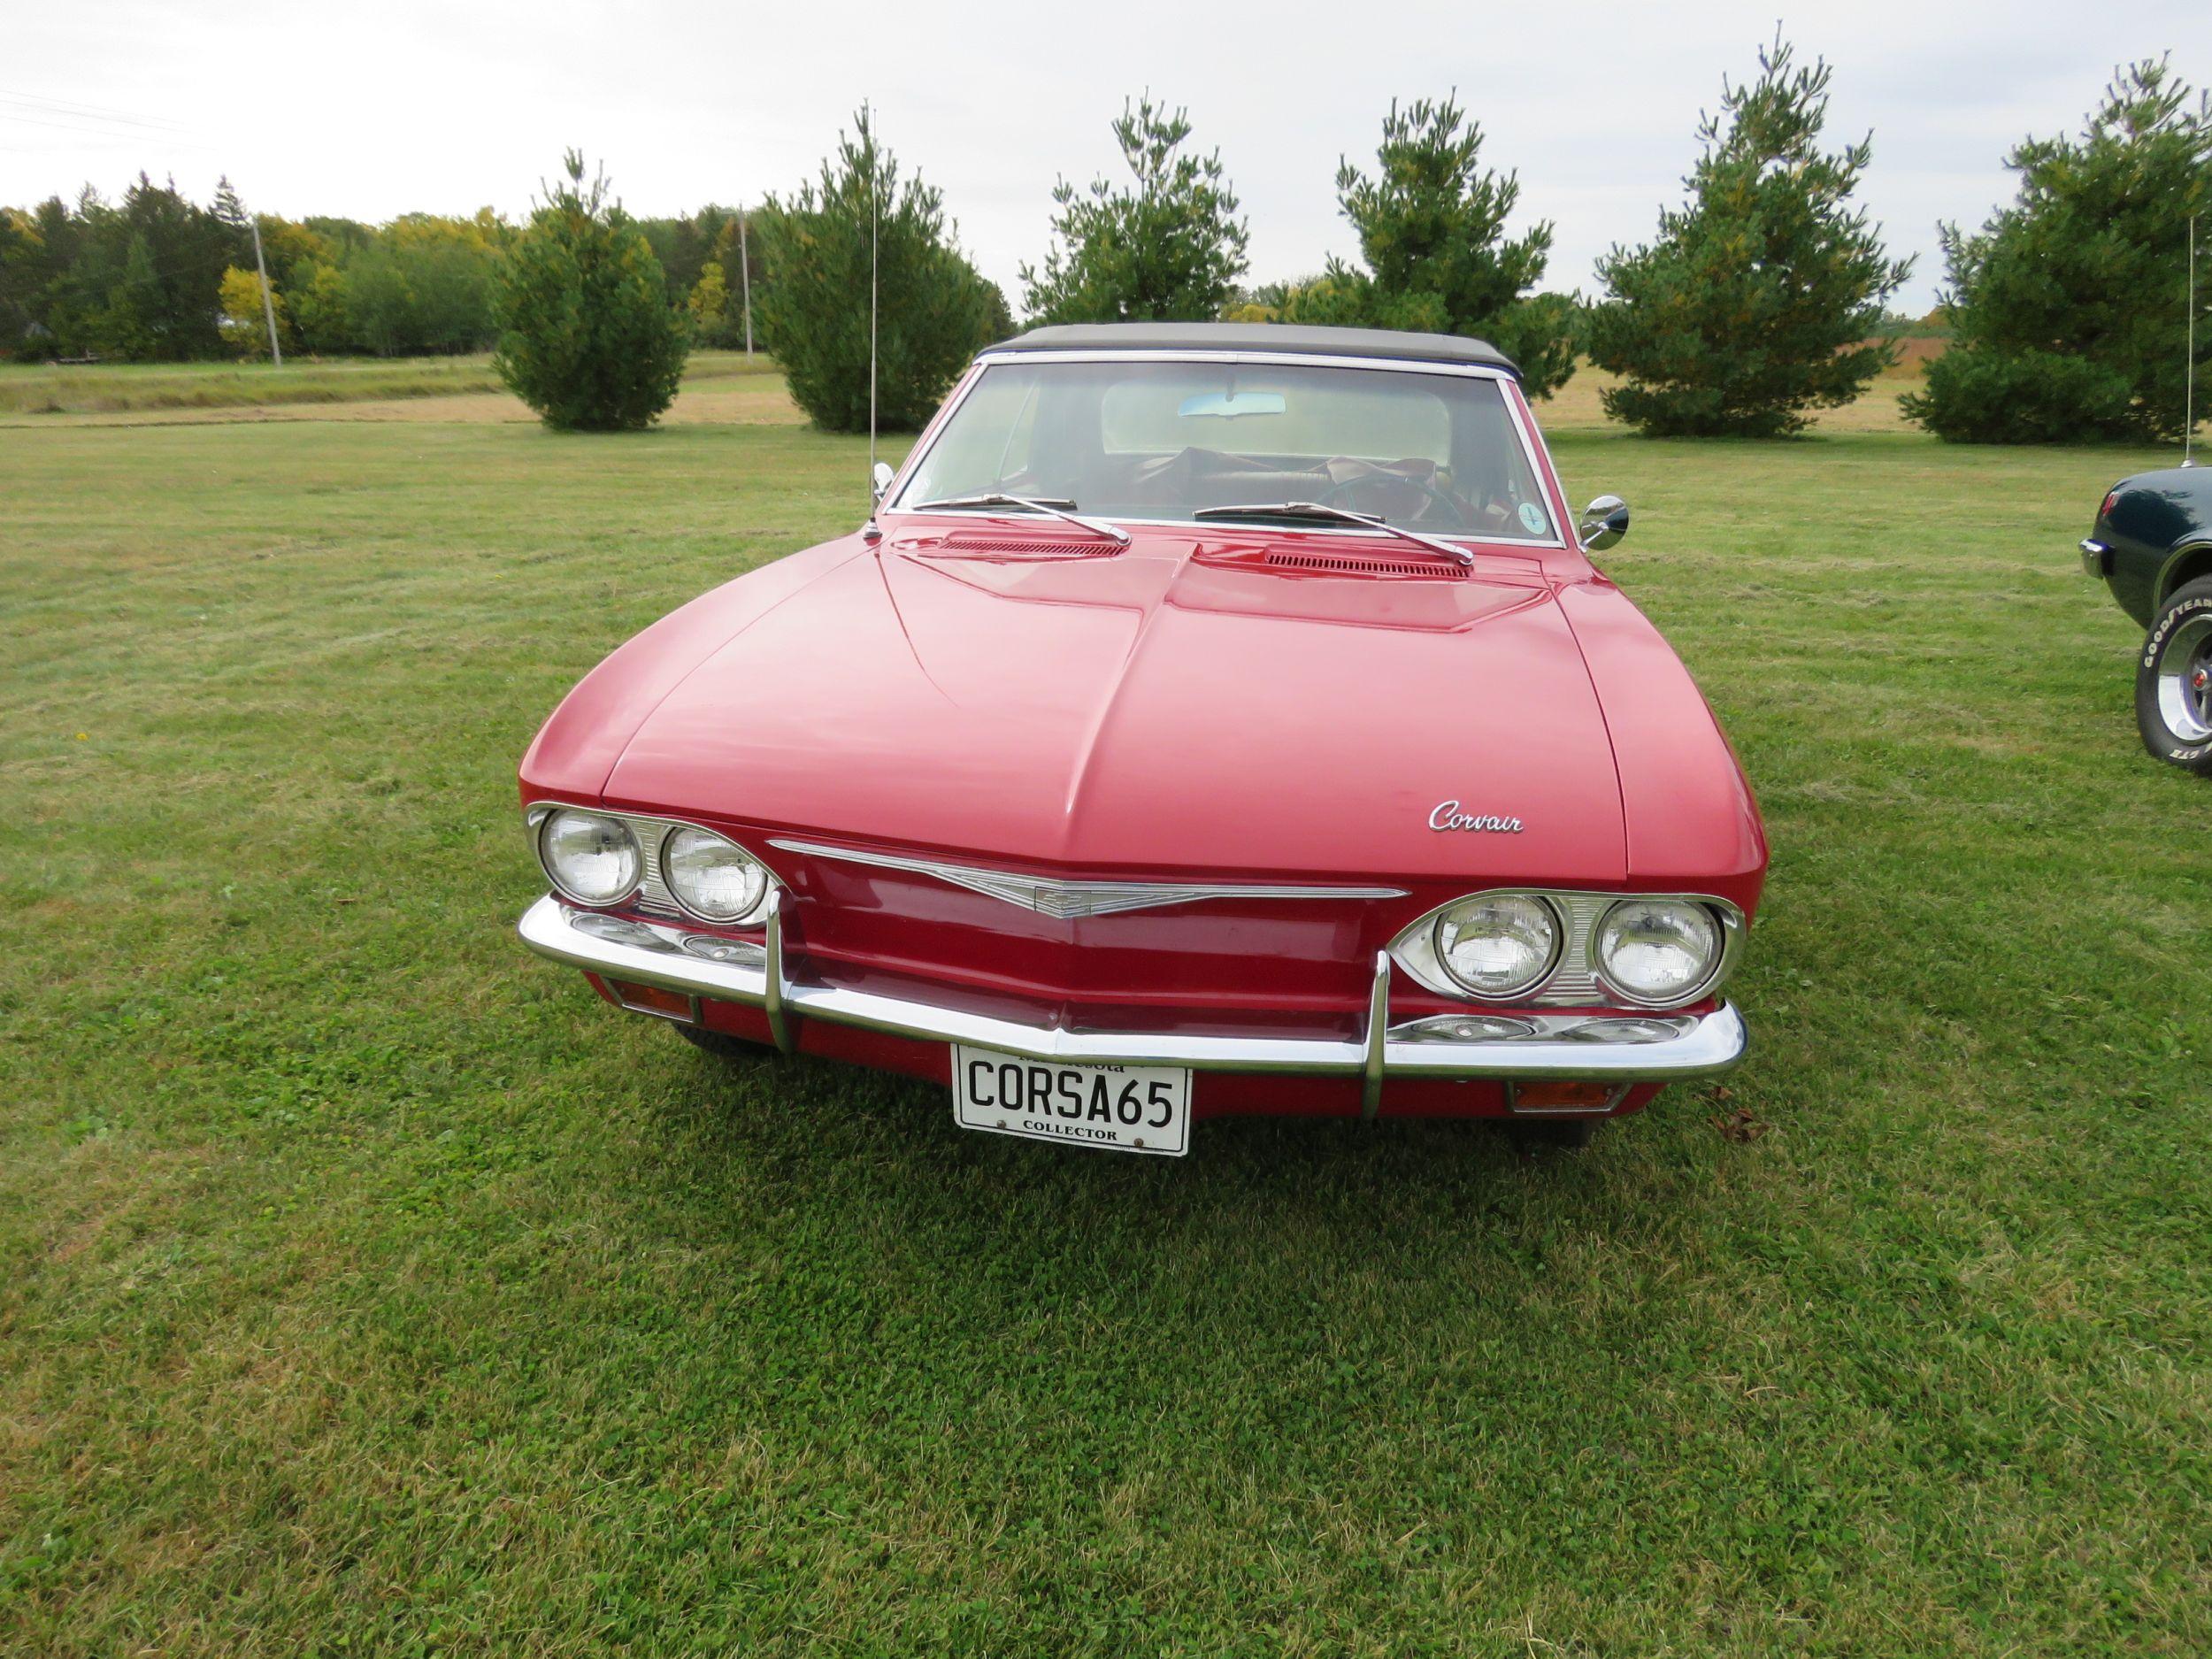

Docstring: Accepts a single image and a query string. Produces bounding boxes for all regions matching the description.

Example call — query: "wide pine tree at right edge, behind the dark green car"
[1902,60,2212,442]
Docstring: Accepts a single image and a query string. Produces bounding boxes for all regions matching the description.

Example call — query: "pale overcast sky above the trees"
[0,0,2212,312]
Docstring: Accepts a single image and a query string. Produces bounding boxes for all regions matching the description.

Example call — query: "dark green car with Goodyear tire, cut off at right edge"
[2082,467,2212,774]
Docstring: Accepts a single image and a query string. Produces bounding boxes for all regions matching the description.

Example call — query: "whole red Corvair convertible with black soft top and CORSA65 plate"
[522,323,1768,1155]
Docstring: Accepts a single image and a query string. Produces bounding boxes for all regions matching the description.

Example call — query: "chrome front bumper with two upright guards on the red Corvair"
[520,894,1746,1118]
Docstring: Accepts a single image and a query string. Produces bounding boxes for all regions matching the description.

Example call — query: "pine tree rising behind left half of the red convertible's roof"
[1022,93,1250,323]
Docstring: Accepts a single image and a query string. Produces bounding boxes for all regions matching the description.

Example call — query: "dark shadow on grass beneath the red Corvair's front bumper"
[628,1053,1712,1294]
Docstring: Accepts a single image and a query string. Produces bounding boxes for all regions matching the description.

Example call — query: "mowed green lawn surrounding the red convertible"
[0,369,2212,1659]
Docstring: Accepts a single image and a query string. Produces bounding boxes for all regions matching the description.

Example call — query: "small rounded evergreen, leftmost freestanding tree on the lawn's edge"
[491,150,690,432]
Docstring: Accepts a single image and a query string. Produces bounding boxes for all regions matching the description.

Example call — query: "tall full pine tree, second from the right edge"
[1588,35,1911,438]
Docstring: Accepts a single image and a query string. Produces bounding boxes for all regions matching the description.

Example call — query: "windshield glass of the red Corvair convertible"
[894,358,1557,542]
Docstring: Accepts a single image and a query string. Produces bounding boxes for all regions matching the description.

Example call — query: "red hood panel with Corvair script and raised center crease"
[606,535,1626,898]
